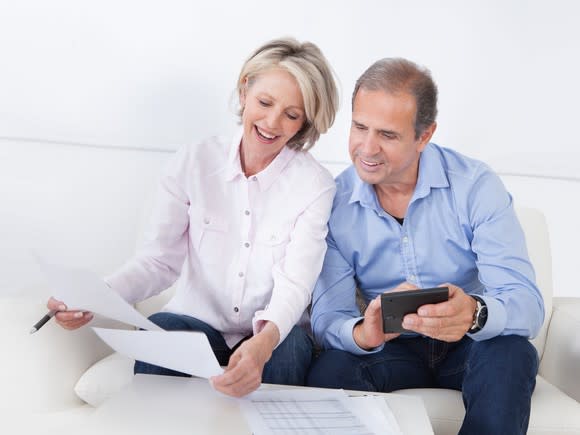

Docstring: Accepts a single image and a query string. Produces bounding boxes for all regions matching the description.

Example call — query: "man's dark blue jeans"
[307,335,538,435]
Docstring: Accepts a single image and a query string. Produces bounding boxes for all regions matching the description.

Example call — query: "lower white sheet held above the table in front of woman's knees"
[93,328,223,378]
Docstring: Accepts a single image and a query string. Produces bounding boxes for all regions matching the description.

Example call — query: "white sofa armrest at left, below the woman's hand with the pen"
[0,297,127,412]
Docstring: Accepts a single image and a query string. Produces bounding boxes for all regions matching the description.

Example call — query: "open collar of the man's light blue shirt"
[349,143,449,210]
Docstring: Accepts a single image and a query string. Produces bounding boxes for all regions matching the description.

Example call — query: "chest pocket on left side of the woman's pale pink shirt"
[193,212,229,265]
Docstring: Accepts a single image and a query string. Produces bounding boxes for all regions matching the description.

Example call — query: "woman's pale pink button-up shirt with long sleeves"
[106,132,336,346]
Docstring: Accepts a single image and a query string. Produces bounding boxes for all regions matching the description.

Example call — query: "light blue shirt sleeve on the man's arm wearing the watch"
[468,172,544,340]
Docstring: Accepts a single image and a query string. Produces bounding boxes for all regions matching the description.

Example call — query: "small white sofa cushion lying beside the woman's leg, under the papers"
[74,352,135,407]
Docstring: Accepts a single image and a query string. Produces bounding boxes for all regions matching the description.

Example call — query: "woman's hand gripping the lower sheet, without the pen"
[210,322,280,397]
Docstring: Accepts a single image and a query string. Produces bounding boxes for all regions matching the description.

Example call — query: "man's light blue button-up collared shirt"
[312,144,544,354]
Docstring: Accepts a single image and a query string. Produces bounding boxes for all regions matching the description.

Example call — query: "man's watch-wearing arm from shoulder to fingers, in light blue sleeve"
[403,170,544,342]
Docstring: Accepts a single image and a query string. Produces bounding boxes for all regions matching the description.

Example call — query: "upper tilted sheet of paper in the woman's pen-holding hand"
[35,255,162,331]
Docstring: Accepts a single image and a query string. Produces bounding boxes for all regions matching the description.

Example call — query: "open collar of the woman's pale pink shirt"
[226,128,298,190]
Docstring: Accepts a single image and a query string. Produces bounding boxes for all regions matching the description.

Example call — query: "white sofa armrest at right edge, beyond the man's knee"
[540,298,580,402]
